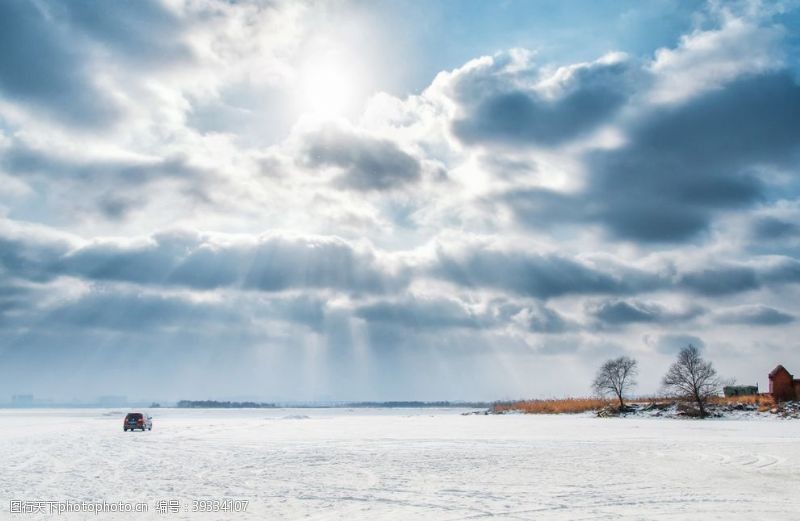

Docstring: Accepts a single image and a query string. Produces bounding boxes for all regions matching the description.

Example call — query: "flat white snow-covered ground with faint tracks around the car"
[0,409,800,520]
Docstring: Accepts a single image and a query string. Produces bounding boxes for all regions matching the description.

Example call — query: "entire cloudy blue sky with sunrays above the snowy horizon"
[0,0,800,403]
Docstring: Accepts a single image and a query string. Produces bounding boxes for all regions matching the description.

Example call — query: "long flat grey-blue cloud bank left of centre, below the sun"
[62,234,401,292]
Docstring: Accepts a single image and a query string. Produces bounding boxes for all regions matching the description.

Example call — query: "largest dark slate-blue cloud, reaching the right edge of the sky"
[502,73,800,242]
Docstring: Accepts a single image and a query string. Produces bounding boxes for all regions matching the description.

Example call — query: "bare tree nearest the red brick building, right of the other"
[663,344,720,418]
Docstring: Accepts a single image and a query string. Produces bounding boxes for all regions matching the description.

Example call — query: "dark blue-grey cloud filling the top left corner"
[0,0,192,128]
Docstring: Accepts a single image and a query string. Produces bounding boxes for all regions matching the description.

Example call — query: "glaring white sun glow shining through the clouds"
[300,54,358,117]
